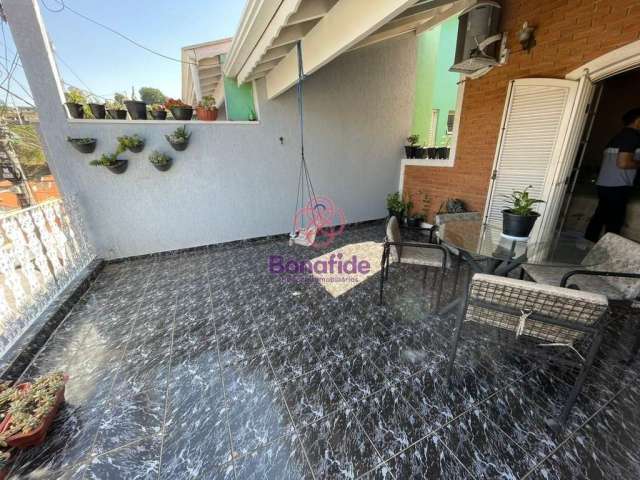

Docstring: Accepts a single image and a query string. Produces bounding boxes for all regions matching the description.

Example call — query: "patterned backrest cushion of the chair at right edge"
[584,233,640,300]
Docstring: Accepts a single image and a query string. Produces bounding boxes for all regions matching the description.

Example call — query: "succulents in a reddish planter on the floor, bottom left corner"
[0,372,67,448]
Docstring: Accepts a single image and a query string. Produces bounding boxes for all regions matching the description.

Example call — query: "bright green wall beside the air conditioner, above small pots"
[412,17,459,146]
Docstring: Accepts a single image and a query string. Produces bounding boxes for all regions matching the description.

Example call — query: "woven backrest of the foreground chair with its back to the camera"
[465,274,608,345]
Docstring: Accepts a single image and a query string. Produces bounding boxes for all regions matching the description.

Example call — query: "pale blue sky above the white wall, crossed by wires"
[0,0,245,104]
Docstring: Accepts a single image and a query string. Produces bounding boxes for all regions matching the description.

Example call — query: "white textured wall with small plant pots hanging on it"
[3,0,416,258]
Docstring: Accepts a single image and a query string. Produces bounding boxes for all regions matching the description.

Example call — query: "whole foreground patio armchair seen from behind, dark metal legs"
[447,274,608,429]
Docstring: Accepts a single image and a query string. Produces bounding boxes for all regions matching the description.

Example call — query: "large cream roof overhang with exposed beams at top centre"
[223,0,476,98]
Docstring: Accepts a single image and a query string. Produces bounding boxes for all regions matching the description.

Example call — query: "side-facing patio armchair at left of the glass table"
[380,217,448,311]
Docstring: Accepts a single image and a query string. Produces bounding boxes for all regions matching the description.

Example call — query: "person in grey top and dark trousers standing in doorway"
[584,108,640,242]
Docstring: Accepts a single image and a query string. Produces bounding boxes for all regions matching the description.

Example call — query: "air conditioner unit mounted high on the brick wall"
[449,1,502,75]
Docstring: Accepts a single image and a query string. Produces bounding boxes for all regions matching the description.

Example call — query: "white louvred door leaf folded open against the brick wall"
[485,75,595,248]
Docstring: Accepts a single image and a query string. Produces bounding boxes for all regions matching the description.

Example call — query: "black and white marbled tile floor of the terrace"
[10,224,640,480]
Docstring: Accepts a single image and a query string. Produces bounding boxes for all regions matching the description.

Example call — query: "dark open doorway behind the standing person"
[558,68,640,241]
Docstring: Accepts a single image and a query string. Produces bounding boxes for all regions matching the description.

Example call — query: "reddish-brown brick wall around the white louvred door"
[404,0,640,219]
